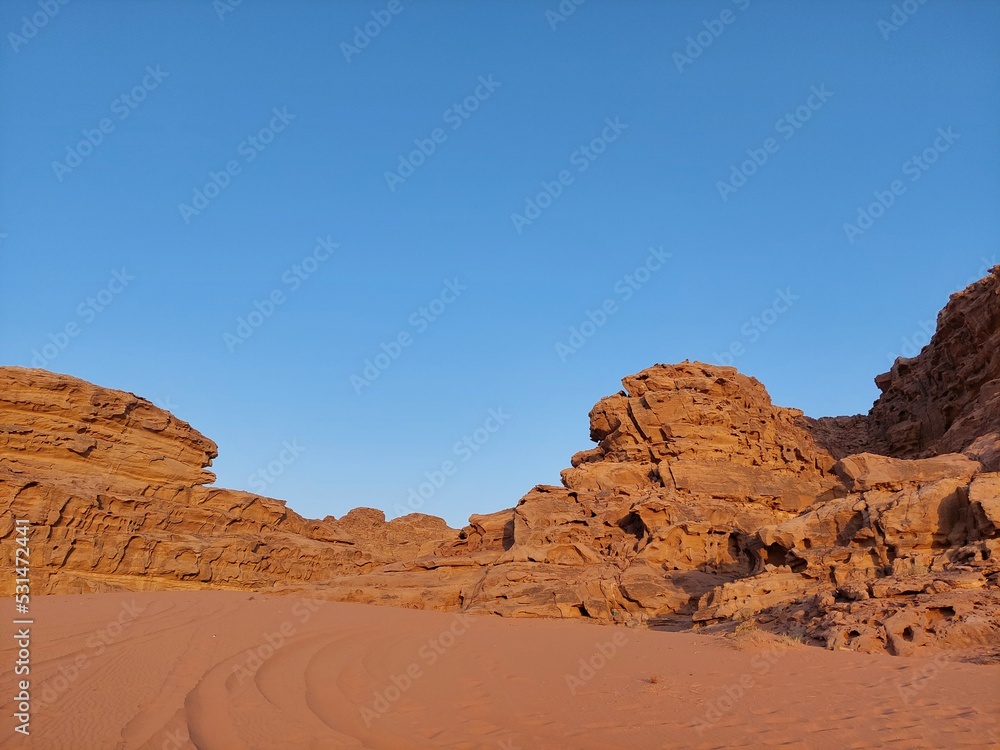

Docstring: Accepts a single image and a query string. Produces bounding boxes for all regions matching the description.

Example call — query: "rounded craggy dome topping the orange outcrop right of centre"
[562,363,837,510]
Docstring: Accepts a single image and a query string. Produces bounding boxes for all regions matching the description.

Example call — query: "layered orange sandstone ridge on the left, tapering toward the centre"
[0,368,458,593]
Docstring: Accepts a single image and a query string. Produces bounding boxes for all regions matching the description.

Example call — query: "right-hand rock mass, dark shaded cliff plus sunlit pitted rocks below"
[680,267,1000,657]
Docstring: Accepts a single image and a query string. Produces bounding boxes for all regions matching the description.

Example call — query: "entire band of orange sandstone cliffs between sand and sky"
[0,267,1000,656]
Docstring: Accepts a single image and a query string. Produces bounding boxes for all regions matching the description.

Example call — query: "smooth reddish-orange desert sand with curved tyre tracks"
[0,592,1000,750]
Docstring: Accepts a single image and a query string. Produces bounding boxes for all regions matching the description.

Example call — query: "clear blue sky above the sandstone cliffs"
[0,0,1000,525]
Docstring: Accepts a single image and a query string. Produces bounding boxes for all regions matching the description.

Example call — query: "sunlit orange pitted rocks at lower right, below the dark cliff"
[693,472,1000,654]
